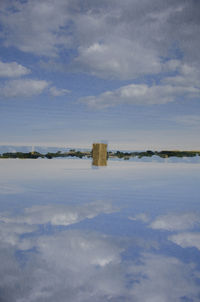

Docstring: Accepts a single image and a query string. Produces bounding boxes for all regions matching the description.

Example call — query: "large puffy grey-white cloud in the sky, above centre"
[75,38,162,79]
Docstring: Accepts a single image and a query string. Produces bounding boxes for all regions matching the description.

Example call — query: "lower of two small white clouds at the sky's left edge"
[0,79,49,98]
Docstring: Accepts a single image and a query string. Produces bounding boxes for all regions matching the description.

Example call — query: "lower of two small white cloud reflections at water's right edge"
[168,232,200,250]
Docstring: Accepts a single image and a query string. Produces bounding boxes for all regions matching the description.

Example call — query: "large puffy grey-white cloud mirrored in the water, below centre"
[37,231,124,271]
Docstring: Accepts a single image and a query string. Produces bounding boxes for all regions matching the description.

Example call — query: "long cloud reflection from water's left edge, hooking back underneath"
[0,202,116,250]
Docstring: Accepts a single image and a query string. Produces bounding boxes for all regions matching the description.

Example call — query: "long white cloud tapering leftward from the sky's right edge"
[80,60,200,109]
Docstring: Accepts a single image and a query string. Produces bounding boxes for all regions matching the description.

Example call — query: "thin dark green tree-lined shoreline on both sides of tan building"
[0,149,200,160]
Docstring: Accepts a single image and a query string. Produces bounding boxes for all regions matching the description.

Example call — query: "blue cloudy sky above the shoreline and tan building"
[0,0,200,150]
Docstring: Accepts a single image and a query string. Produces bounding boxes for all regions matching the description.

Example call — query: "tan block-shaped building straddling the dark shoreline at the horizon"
[92,143,107,166]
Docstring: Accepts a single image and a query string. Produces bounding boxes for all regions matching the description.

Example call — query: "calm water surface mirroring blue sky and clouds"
[0,159,200,302]
